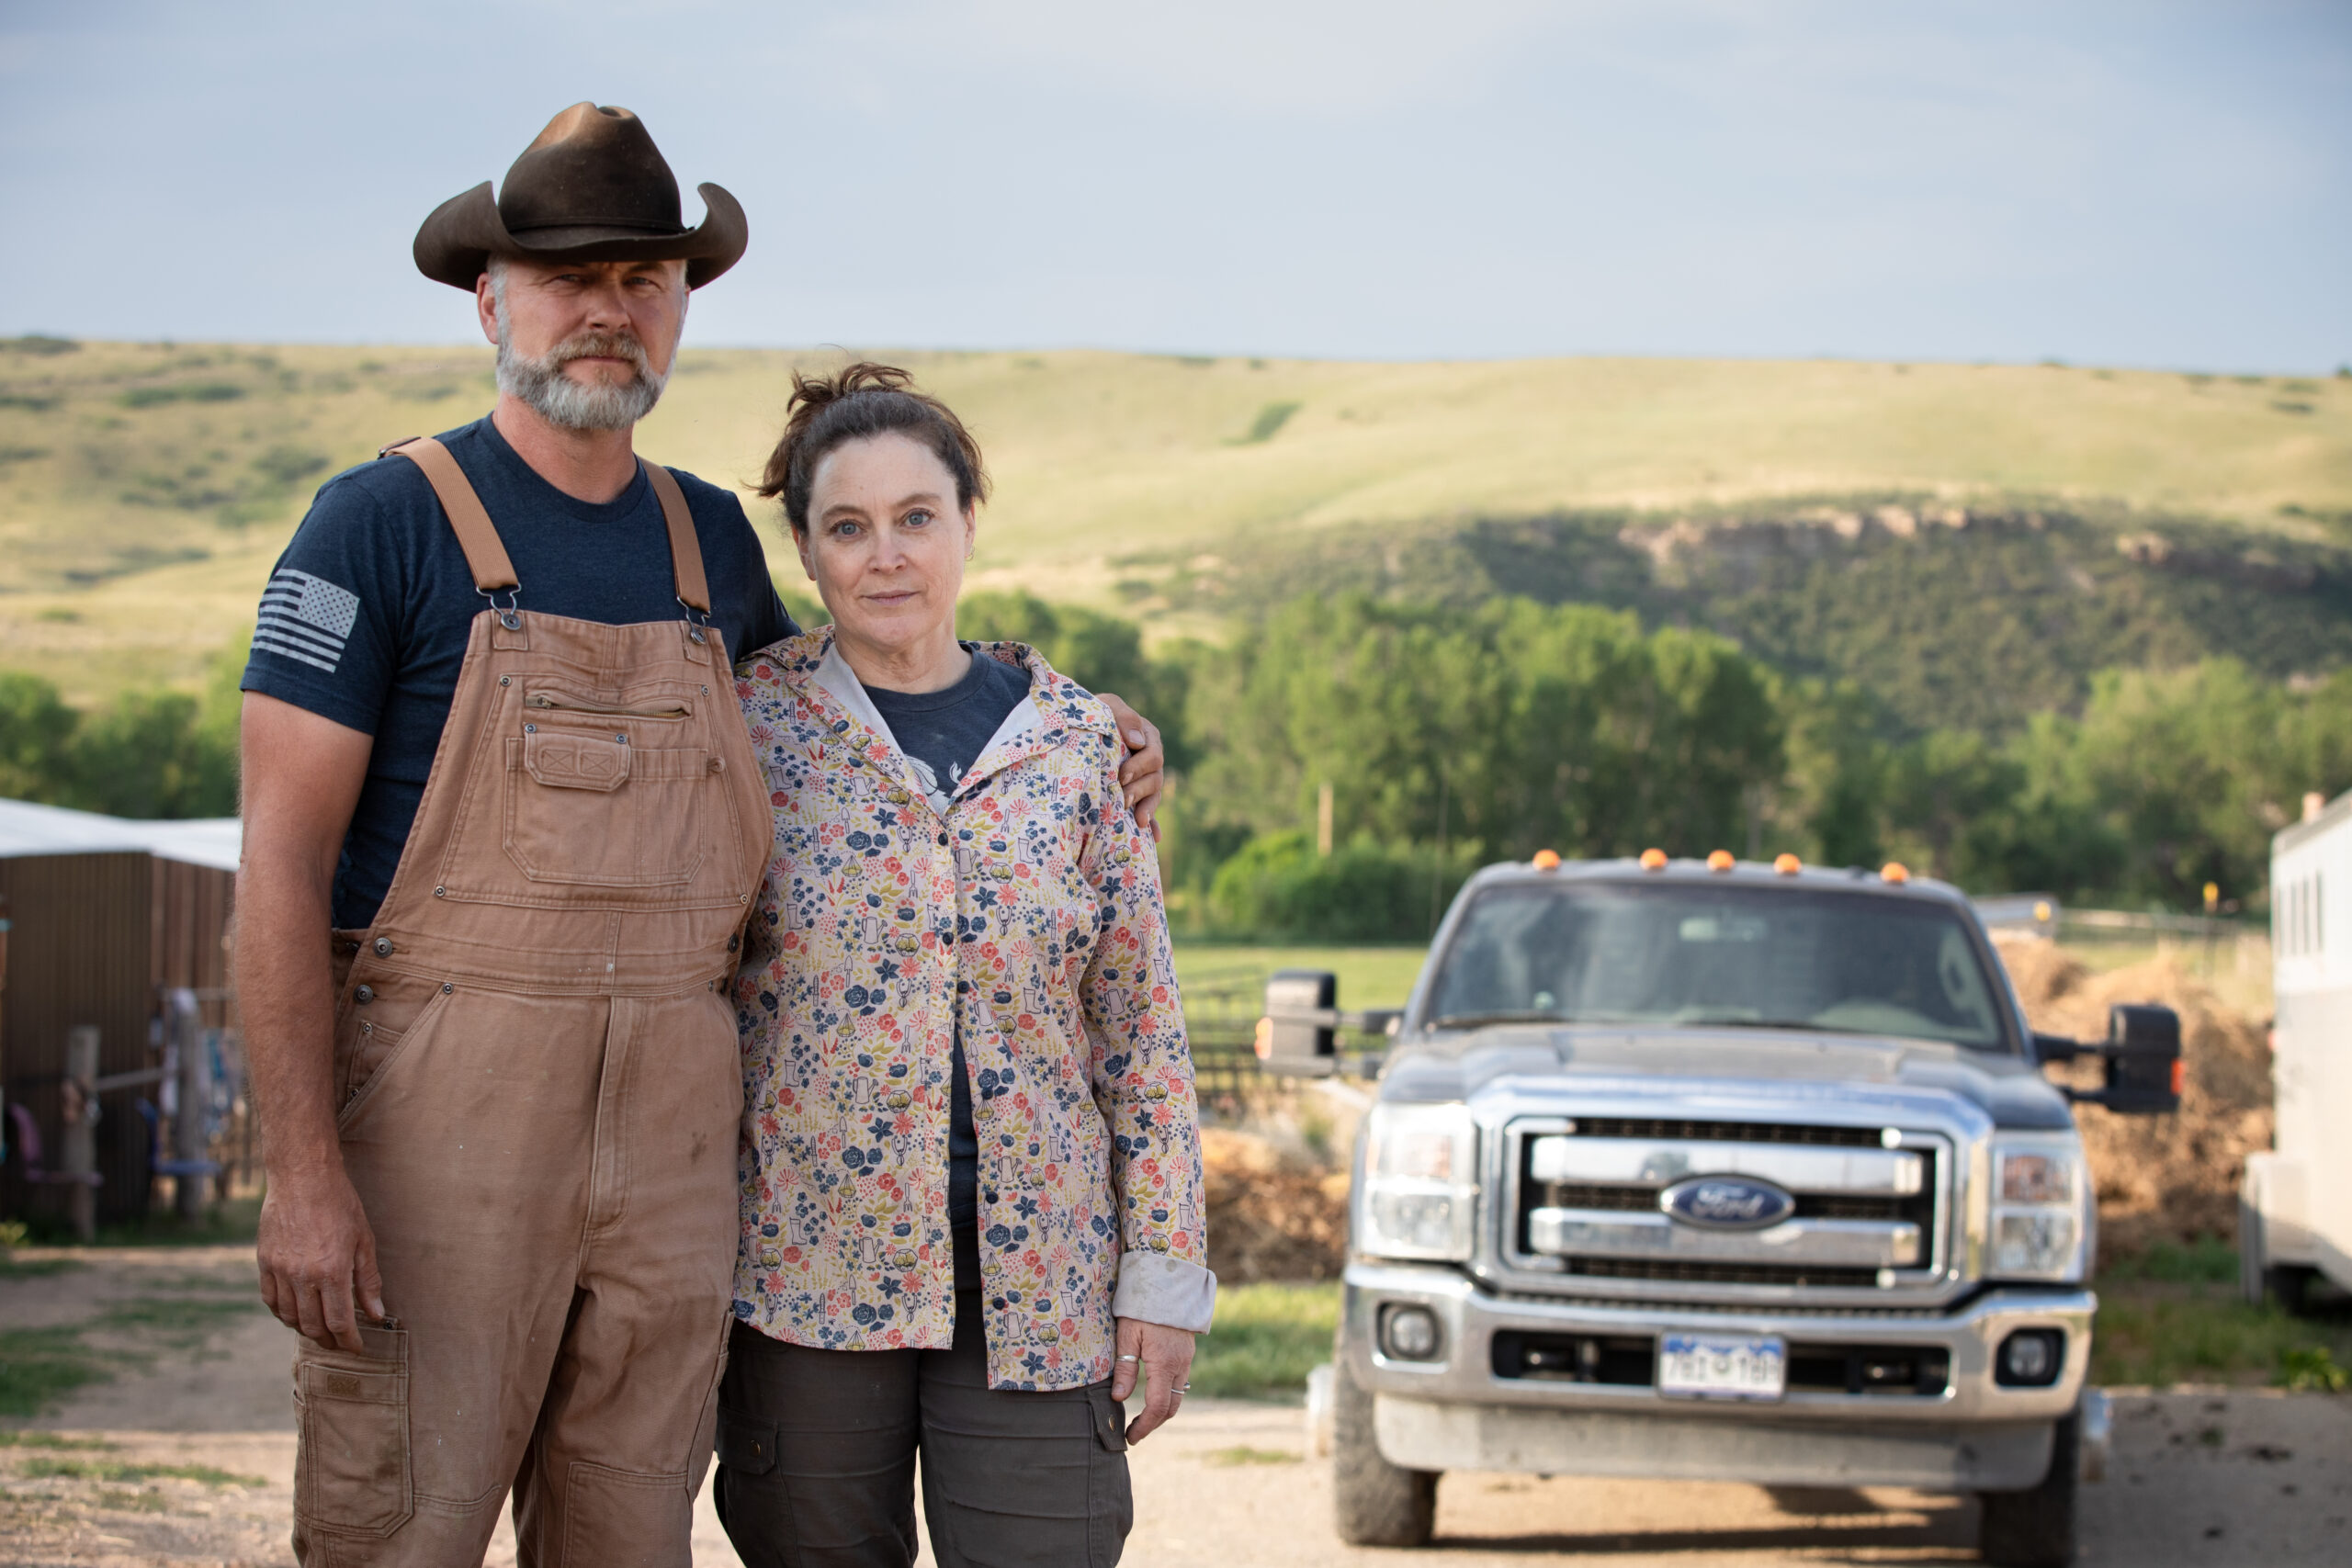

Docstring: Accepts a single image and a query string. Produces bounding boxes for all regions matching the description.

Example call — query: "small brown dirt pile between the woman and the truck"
[1200,1126,1348,1286]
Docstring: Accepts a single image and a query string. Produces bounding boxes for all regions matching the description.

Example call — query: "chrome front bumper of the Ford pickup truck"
[1340,1262,2098,1491]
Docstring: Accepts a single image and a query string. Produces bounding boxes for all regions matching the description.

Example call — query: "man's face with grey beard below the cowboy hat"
[475,261,687,430]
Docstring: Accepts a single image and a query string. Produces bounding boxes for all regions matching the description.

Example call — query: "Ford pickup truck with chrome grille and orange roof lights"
[1259,851,2180,1565]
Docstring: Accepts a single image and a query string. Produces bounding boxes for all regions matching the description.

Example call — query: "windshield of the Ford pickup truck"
[1430,882,2004,1051]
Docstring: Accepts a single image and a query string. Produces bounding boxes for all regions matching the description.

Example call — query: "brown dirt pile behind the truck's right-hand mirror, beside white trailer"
[1999,938,2272,1256]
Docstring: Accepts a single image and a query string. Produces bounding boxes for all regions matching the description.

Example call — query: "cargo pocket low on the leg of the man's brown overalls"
[294,1325,416,1535]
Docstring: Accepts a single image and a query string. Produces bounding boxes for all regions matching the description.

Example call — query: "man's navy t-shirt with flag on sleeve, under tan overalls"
[240,419,795,929]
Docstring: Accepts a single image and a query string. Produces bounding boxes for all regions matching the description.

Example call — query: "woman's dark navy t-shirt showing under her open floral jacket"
[865,642,1028,1291]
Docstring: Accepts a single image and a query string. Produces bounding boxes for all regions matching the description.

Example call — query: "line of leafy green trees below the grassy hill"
[0,592,2352,941]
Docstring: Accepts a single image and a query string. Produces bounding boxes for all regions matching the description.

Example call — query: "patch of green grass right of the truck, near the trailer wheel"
[2091,1279,2352,1387]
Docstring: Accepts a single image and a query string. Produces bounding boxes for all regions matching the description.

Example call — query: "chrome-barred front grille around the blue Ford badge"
[1505,1117,1950,1291]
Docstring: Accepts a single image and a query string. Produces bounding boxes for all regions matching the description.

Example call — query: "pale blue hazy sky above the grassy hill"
[0,0,2352,371]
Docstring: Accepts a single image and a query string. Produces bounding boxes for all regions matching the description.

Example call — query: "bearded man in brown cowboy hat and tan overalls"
[238,104,1159,1568]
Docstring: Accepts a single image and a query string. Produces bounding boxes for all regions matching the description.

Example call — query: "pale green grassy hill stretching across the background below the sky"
[0,339,2352,705]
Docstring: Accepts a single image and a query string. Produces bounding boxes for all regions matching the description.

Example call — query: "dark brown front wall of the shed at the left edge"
[0,853,158,1223]
